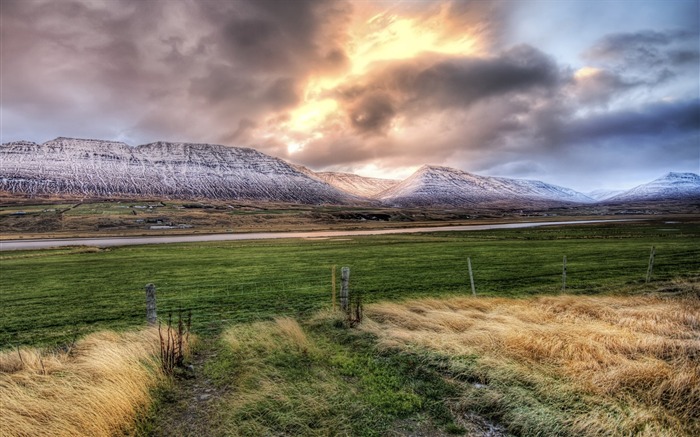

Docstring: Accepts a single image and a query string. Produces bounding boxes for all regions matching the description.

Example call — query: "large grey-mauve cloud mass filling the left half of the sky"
[1,0,350,142]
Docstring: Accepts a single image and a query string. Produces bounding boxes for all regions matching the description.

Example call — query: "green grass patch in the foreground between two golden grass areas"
[150,315,460,436]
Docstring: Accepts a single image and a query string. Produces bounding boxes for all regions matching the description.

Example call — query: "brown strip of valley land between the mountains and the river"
[0,194,700,241]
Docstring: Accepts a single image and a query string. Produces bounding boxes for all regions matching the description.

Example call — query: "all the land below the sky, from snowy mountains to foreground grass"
[0,138,700,437]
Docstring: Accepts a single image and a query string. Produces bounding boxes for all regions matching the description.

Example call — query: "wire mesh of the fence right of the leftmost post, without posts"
[146,244,700,329]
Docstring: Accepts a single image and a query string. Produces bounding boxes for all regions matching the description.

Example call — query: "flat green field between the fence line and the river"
[0,222,700,348]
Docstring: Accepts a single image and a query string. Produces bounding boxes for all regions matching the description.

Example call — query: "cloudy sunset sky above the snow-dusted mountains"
[0,0,700,191]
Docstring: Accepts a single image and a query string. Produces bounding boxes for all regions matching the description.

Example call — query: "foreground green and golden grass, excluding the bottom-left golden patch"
[146,281,700,437]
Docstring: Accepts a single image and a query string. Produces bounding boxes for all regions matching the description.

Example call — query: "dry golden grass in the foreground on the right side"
[364,283,700,435]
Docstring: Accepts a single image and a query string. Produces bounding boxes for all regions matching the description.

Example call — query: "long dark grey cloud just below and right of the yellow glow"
[336,45,566,133]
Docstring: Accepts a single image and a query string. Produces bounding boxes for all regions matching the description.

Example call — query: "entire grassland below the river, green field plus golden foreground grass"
[0,220,700,436]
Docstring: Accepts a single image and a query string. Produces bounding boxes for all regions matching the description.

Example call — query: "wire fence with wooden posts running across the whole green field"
[0,244,700,348]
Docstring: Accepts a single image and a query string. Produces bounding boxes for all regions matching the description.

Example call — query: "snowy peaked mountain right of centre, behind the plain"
[377,165,594,207]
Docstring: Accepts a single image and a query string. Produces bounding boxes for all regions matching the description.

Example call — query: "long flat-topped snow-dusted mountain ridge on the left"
[0,138,358,204]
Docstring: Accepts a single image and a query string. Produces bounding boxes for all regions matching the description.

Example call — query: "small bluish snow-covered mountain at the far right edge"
[605,172,700,203]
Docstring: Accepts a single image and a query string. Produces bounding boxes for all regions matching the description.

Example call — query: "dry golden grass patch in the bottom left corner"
[0,329,162,437]
